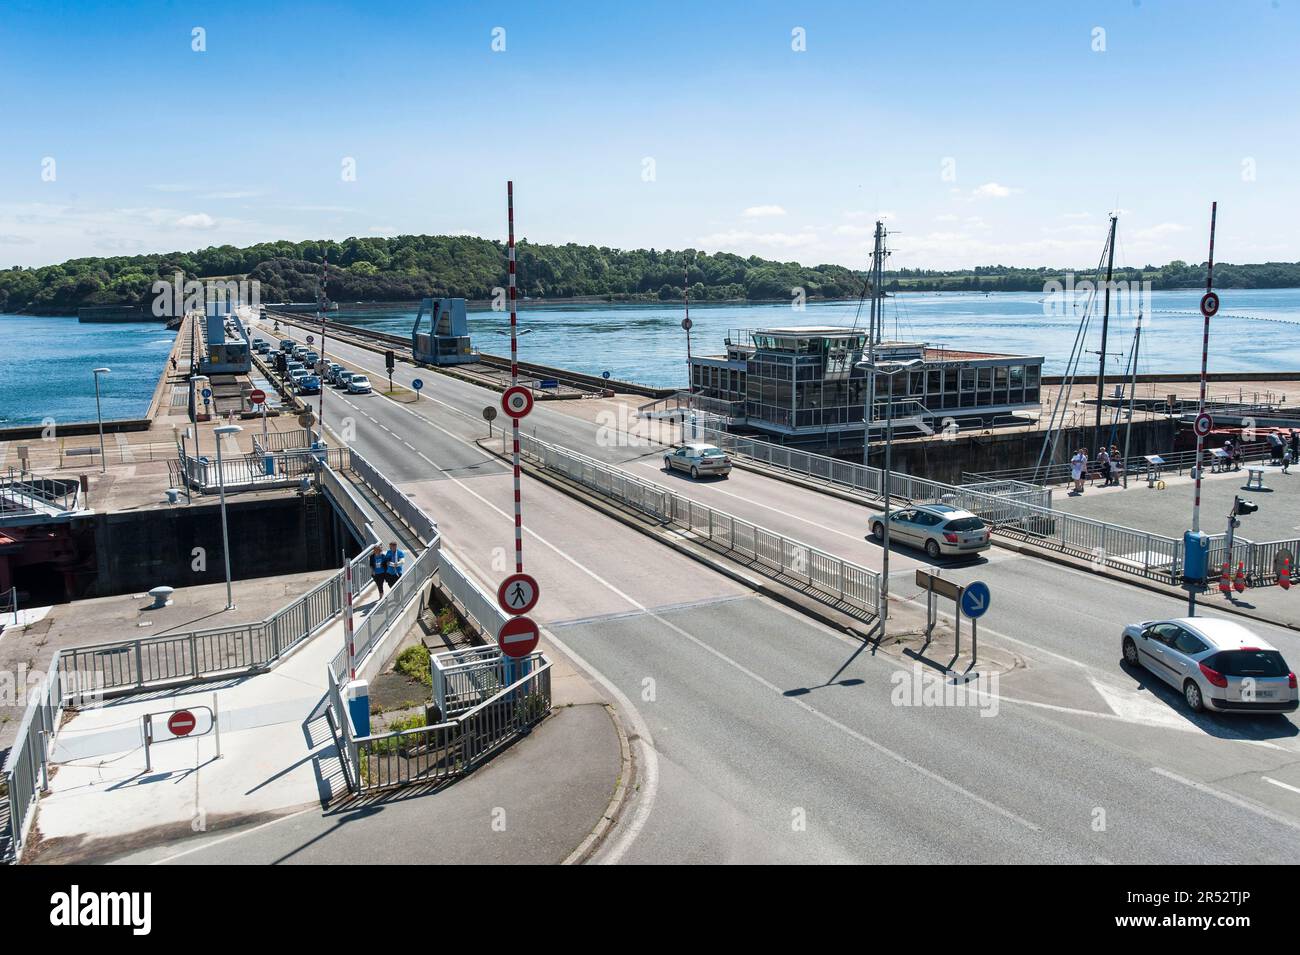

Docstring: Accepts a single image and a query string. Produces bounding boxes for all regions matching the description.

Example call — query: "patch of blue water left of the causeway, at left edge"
[0,314,176,427]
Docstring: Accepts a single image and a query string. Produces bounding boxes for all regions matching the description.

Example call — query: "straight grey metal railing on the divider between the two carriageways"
[520,435,880,615]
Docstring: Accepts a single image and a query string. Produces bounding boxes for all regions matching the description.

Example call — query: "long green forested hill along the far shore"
[0,235,1300,314]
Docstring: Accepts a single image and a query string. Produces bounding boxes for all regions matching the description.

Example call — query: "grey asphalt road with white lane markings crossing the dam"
[250,320,1300,863]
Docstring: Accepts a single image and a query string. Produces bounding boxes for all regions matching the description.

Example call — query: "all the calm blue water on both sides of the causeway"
[0,288,1300,427]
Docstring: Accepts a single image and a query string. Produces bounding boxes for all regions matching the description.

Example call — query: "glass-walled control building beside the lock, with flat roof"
[692,327,1043,440]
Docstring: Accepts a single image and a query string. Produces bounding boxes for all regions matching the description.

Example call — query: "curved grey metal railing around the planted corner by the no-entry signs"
[326,655,551,793]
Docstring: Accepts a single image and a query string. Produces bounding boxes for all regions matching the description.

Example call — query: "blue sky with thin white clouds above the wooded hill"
[0,0,1300,269]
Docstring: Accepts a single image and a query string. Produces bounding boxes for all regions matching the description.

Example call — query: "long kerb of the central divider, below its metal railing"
[477,438,920,641]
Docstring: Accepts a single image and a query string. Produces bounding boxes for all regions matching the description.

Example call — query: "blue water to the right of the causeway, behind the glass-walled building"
[338,288,1300,386]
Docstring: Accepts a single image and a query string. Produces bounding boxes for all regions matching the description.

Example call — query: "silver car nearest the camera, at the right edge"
[1121,617,1300,713]
